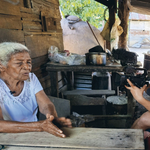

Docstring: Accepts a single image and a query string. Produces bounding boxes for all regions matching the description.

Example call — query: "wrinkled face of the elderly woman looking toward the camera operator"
[5,51,32,81]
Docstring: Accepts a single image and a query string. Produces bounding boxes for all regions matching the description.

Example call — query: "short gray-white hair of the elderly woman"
[0,42,29,66]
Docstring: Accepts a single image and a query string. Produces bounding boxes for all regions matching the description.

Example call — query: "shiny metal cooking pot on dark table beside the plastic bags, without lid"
[85,52,106,66]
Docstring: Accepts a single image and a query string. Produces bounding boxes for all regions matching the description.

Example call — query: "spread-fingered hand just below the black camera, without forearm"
[125,79,147,103]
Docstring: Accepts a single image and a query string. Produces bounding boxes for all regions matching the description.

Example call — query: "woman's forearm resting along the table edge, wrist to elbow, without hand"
[0,120,43,133]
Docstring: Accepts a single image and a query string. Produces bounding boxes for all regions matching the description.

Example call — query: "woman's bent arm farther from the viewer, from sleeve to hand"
[36,90,72,127]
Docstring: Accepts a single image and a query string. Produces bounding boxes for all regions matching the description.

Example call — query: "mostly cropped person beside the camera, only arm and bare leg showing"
[125,79,150,139]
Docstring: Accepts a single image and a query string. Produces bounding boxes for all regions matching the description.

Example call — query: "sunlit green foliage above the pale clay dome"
[59,0,108,28]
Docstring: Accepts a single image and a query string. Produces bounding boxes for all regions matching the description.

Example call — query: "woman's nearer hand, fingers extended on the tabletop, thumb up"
[41,114,66,138]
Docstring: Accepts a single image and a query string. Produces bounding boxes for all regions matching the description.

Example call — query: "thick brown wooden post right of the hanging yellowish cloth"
[118,0,129,49]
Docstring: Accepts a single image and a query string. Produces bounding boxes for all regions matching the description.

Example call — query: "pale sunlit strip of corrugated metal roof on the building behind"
[129,12,150,20]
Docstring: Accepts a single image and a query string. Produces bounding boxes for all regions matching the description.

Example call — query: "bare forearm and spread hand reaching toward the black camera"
[125,79,150,111]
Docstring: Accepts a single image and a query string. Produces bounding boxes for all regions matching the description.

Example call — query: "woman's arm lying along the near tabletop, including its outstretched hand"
[0,108,65,137]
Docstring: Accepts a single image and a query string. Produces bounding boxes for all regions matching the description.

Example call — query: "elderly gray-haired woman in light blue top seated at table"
[0,42,72,137]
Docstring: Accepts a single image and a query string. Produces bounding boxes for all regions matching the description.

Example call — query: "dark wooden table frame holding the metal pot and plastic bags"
[46,62,134,118]
